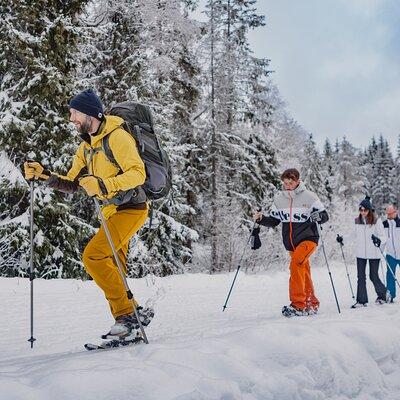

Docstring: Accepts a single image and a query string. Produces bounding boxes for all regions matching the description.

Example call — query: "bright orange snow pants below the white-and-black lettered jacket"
[289,240,319,310]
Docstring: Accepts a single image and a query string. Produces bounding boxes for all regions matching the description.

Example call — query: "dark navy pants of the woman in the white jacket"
[357,258,386,304]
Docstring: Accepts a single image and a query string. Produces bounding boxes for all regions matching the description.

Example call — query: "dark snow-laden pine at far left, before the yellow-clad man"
[0,0,93,277]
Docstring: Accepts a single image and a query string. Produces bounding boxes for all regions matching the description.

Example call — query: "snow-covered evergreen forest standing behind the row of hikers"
[0,0,399,278]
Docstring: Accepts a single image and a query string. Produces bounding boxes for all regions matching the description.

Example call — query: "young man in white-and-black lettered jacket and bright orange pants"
[253,168,329,317]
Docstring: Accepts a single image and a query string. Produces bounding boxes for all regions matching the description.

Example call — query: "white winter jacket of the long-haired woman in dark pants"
[355,218,387,259]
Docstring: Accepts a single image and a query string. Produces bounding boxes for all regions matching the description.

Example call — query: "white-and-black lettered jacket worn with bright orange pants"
[259,182,329,251]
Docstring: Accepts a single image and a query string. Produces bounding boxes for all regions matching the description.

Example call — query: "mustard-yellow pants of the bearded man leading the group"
[82,209,148,317]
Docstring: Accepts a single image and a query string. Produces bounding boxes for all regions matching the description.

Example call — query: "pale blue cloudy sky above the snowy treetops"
[192,0,400,150]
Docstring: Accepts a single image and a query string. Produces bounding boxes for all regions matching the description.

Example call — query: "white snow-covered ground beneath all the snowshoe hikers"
[0,264,400,400]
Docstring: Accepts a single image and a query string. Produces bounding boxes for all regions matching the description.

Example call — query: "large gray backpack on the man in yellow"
[103,101,172,200]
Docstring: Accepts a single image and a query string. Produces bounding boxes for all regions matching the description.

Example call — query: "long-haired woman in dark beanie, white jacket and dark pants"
[351,196,391,308]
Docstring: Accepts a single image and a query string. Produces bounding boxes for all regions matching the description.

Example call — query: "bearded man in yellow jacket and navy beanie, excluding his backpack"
[24,89,153,337]
